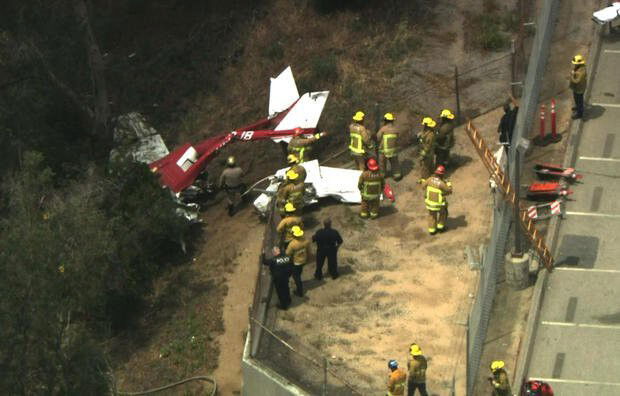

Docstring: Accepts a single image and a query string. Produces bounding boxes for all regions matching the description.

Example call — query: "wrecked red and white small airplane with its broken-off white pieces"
[111,66,394,220]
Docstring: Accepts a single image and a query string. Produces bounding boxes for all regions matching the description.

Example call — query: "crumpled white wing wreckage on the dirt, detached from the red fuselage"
[254,160,362,213]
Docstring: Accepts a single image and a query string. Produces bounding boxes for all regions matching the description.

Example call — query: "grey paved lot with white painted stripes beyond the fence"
[528,33,620,396]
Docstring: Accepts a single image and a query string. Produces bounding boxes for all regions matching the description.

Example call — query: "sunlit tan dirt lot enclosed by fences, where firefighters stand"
[275,111,508,395]
